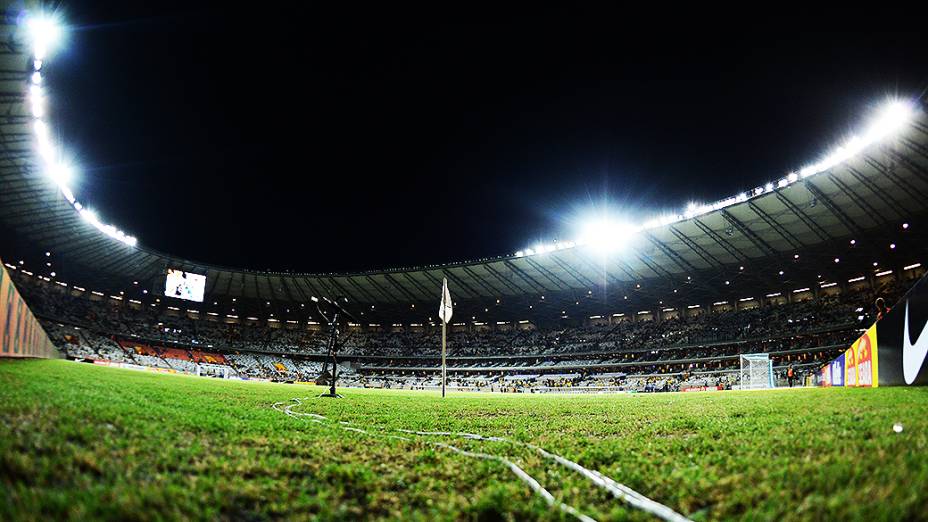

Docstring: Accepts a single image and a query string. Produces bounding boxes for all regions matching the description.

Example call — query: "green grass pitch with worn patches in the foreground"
[0,361,928,520]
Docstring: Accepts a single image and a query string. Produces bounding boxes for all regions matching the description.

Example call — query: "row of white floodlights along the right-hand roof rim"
[517,100,916,256]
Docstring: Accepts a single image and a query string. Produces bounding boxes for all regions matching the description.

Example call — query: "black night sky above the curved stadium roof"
[48,3,928,272]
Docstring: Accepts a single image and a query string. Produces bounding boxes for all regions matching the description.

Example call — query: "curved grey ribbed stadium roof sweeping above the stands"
[0,12,928,320]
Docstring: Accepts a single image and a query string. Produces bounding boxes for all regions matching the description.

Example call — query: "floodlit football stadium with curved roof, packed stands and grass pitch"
[0,6,928,520]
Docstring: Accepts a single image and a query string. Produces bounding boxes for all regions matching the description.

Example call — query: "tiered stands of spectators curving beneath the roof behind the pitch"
[10,266,903,389]
